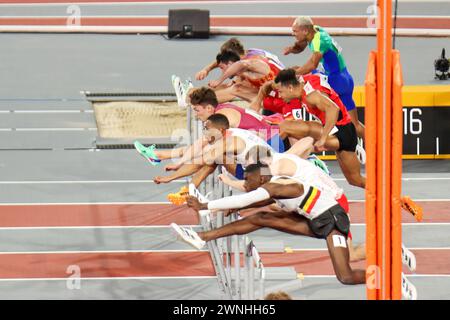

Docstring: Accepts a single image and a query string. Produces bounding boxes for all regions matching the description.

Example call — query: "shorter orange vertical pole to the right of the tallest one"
[391,50,403,300]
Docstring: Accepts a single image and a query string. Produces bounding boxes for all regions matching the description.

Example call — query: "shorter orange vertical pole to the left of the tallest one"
[364,51,379,300]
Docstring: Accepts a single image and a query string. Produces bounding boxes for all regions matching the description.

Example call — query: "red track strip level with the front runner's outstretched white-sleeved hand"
[0,201,450,227]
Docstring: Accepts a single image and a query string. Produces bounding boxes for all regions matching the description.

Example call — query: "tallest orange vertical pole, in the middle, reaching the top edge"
[376,0,392,300]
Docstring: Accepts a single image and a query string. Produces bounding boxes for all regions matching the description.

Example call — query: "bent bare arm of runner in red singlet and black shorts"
[306,91,339,151]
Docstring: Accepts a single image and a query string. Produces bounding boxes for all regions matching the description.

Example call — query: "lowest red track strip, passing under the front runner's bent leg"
[0,250,450,278]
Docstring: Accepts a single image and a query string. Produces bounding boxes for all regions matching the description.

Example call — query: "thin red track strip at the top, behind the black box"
[0,16,450,29]
